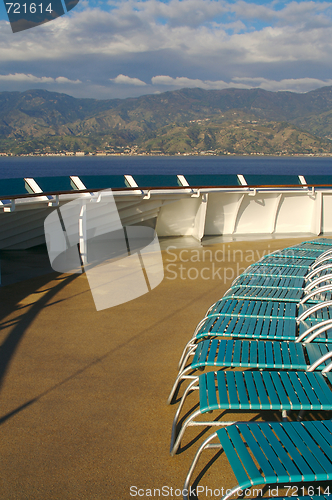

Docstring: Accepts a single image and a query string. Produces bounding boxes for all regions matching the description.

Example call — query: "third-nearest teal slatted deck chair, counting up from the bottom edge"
[167,339,332,404]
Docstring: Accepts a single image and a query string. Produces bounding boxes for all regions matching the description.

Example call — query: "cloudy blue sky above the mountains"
[0,0,332,99]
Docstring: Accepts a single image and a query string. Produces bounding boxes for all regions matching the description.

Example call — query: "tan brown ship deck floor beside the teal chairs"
[0,237,330,500]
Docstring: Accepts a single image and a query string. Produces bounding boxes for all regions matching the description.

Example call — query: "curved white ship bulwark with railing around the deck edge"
[0,176,332,249]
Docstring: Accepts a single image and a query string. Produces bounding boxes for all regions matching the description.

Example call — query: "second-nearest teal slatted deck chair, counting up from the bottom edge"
[170,372,332,455]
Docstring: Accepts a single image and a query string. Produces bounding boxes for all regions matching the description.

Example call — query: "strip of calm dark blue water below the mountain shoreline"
[0,156,332,179]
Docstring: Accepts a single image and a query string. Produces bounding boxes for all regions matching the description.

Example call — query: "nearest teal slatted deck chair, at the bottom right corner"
[183,420,332,500]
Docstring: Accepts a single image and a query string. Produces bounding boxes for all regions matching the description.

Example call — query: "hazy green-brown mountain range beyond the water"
[0,87,332,154]
